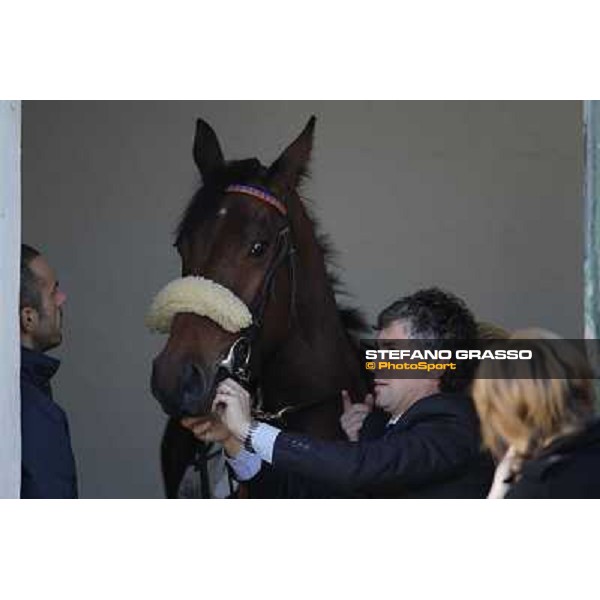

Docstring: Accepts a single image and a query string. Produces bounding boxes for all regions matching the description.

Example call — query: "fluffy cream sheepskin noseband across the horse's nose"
[146,275,252,333]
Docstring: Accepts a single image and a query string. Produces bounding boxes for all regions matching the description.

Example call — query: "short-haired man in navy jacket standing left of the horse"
[19,245,77,498]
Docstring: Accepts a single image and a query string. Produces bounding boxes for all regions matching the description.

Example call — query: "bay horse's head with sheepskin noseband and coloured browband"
[149,117,315,417]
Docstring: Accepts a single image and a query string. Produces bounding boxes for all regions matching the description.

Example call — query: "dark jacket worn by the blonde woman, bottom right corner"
[506,420,600,498]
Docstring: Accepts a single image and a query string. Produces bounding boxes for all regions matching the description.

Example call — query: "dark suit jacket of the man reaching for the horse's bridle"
[255,394,494,498]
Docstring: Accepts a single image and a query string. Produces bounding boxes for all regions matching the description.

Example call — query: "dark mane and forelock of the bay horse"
[175,158,369,341]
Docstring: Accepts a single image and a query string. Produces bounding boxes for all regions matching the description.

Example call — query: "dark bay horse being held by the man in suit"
[151,117,367,497]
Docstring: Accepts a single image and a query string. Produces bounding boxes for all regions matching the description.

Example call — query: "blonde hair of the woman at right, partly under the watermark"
[473,329,594,458]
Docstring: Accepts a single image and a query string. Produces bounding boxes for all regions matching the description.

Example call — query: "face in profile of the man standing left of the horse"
[29,256,67,352]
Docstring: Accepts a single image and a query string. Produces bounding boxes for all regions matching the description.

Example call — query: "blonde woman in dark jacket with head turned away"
[473,329,600,498]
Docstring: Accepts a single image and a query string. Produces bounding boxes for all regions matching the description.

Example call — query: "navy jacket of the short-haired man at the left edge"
[21,348,77,498]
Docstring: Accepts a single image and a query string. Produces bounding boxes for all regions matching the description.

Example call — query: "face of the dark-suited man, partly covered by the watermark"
[375,321,439,417]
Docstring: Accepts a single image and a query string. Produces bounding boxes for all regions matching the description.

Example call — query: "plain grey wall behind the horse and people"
[23,102,583,497]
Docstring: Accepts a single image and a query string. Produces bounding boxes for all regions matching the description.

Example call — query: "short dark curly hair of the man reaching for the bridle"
[377,287,478,392]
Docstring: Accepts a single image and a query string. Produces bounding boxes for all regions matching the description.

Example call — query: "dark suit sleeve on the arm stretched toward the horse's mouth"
[273,412,478,491]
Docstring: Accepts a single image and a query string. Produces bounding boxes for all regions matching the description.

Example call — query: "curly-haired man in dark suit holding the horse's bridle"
[188,288,494,498]
